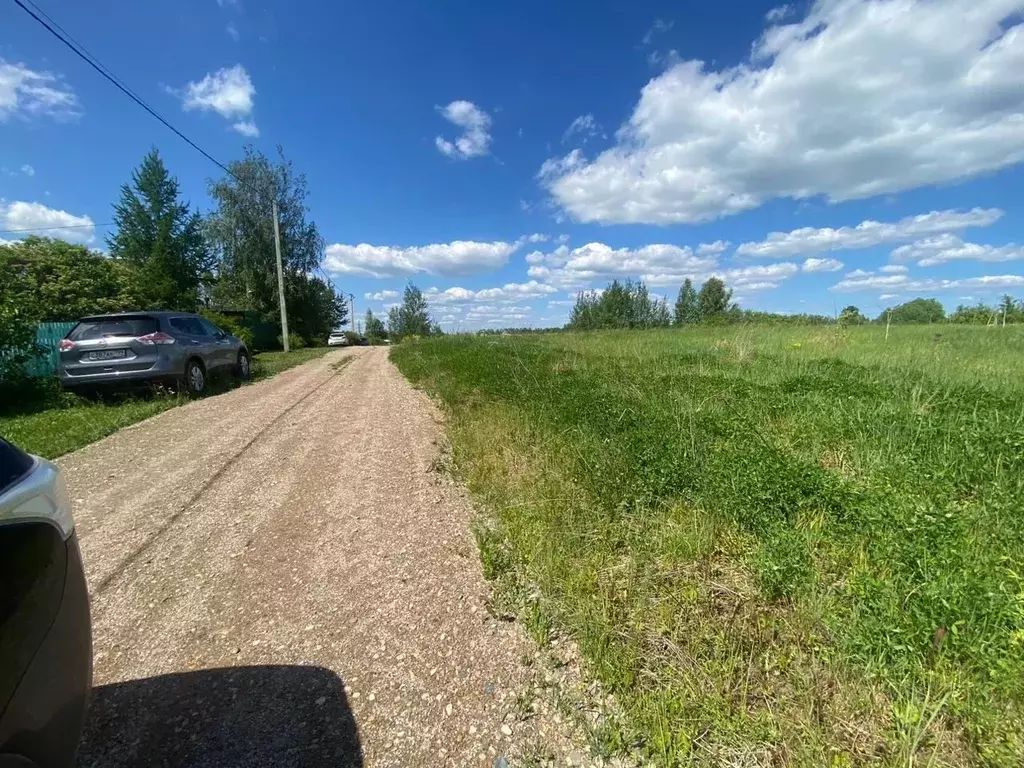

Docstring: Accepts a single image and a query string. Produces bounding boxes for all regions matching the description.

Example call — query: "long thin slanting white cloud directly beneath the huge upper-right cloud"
[736,208,1002,258]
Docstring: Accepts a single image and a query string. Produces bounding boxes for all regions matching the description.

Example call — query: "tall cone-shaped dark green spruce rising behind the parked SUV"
[106,150,212,311]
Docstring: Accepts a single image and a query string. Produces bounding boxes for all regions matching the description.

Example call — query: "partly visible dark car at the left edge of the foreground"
[0,439,92,768]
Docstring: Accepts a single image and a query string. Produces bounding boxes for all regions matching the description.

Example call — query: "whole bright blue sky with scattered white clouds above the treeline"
[0,0,1024,329]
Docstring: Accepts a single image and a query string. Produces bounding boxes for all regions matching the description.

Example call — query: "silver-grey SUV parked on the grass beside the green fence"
[57,311,252,394]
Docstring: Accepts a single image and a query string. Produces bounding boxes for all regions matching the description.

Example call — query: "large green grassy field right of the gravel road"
[391,327,1024,766]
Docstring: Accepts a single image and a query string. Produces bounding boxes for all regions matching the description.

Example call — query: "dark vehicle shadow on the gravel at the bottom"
[78,666,362,768]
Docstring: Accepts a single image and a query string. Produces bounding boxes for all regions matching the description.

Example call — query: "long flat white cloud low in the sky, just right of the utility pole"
[324,240,520,278]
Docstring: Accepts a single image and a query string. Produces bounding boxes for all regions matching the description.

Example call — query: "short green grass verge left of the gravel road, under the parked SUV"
[0,347,328,459]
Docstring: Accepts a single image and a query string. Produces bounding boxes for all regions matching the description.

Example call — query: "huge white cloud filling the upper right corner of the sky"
[542,0,1024,224]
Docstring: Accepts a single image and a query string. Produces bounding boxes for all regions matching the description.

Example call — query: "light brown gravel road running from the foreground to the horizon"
[59,348,577,767]
